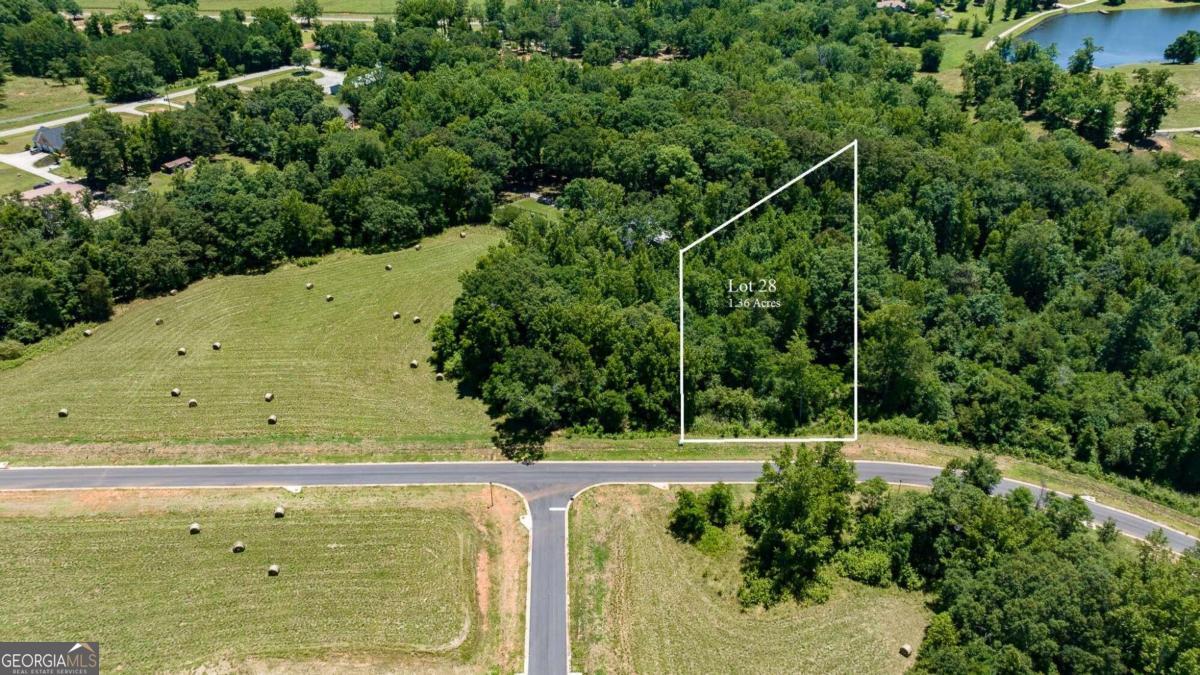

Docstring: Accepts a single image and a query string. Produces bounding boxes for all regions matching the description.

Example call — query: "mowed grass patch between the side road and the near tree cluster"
[570,485,929,673]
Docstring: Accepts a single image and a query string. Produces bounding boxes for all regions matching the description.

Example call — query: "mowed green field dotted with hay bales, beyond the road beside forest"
[0,227,502,443]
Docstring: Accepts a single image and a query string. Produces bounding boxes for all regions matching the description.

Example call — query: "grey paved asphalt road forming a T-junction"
[0,461,1196,675]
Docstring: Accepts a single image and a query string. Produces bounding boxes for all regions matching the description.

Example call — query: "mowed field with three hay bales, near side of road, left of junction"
[0,486,528,673]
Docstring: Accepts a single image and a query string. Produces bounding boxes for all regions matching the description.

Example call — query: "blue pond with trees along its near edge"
[1019,6,1200,67]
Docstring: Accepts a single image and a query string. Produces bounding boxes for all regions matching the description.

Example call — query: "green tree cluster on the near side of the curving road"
[668,444,1200,673]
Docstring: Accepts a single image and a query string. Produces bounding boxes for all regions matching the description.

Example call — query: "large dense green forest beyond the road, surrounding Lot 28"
[0,0,1200,490]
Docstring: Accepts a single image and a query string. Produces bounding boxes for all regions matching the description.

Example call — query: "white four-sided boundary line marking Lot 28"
[679,138,858,444]
